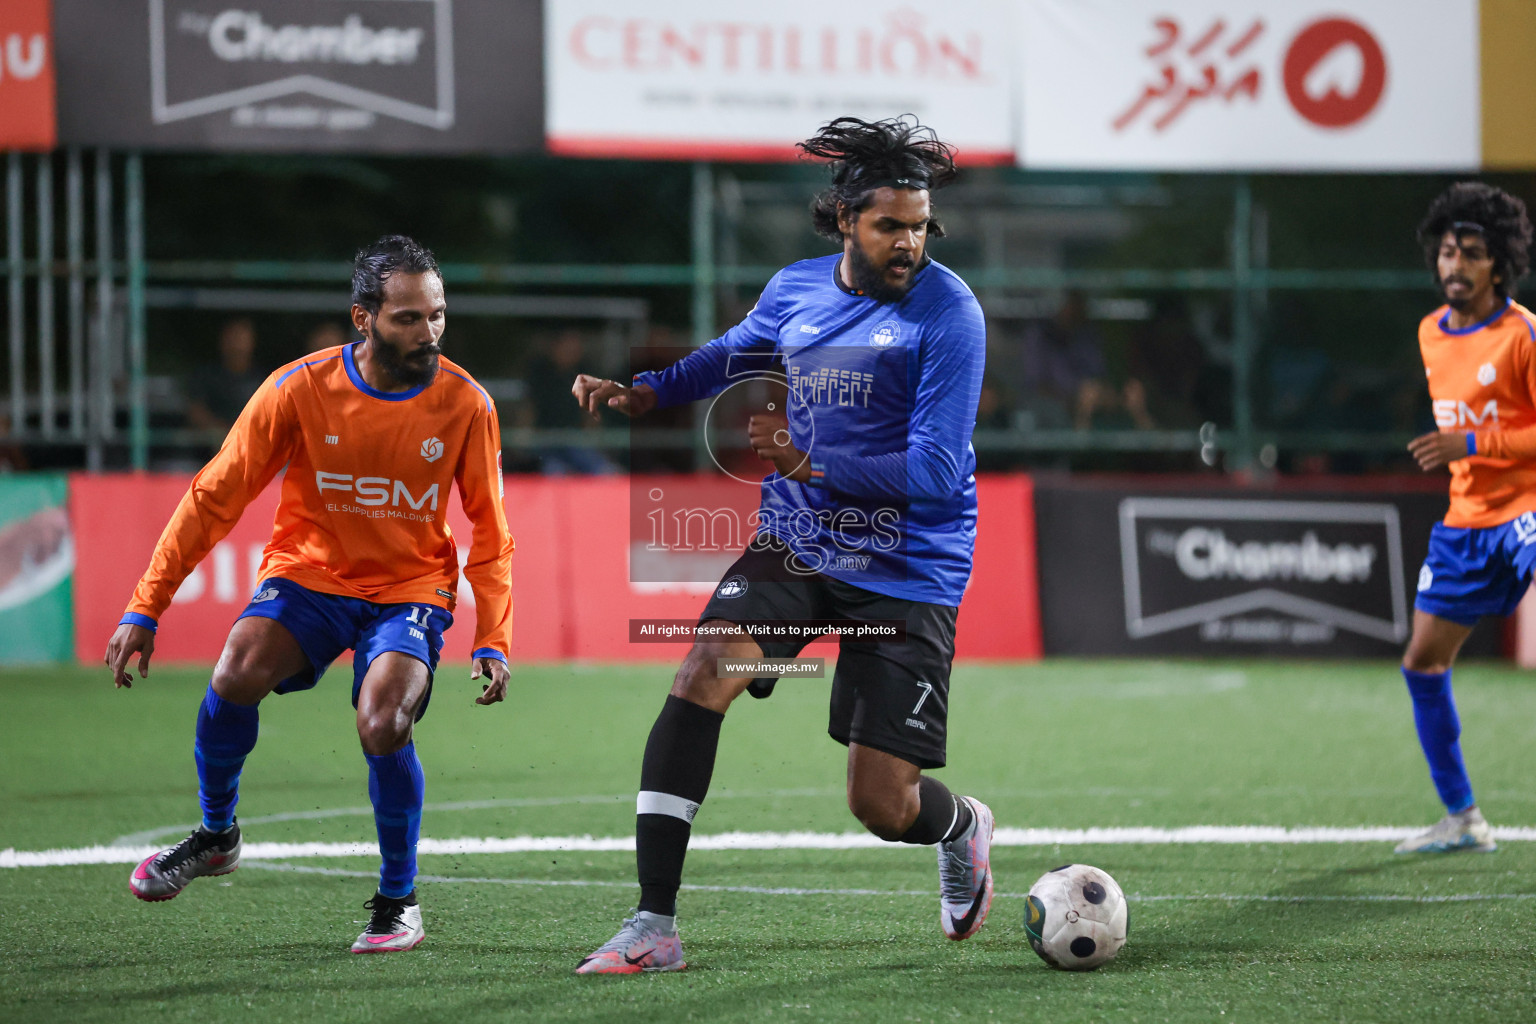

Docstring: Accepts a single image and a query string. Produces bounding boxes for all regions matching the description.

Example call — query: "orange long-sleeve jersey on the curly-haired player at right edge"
[1419,301,1536,528]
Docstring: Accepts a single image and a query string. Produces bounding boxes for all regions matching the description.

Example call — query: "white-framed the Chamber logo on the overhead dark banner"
[149,0,455,132]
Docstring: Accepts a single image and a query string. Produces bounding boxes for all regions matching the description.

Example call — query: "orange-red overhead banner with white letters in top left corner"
[0,0,57,150]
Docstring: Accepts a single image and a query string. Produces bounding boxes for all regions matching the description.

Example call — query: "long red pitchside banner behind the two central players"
[66,473,1040,665]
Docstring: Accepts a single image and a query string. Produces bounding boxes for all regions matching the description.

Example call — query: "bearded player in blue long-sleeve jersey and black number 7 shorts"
[571,118,992,973]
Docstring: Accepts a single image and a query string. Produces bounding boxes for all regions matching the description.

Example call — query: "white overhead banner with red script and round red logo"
[1017,0,1481,170]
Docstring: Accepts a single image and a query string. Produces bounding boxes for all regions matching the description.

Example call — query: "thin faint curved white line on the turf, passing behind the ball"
[241,861,1536,903]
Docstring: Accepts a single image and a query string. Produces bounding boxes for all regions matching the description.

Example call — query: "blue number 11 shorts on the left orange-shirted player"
[240,579,453,722]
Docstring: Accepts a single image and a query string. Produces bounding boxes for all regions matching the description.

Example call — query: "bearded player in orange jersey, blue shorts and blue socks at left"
[106,235,511,953]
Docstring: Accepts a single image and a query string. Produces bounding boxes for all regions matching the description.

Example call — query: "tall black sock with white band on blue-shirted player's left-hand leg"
[634,694,725,917]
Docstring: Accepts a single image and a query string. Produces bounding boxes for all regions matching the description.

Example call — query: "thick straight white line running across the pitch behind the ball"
[9,824,1536,867]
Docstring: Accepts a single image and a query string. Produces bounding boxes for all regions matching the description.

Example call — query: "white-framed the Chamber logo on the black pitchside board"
[1120,497,1409,645]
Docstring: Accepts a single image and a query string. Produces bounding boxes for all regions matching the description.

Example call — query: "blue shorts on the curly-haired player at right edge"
[1413,513,1536,626]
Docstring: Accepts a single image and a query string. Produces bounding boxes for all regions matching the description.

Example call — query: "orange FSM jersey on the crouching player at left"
[127,345,513,657]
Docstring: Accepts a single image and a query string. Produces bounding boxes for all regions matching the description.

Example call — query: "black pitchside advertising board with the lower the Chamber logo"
[1035,482,1501,659]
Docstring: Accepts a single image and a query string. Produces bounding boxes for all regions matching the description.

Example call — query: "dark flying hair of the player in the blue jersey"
[800,114,955,241]
